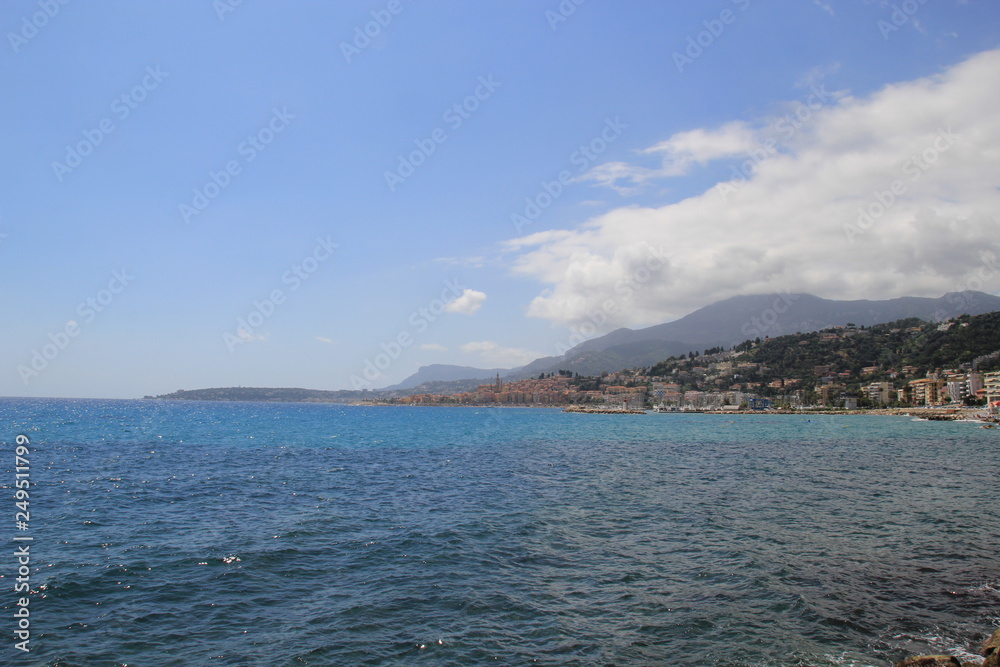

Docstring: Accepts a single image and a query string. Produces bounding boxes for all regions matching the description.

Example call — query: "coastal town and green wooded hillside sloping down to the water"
[378,313,1000,410]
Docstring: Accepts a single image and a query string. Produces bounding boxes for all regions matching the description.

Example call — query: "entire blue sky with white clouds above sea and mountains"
[0,0,1000,398]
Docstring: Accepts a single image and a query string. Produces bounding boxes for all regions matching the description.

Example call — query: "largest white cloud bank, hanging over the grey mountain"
[506,51,1000,326]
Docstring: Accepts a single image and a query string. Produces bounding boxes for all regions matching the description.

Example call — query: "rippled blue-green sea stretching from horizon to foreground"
[0,399,1000,667]
